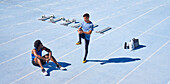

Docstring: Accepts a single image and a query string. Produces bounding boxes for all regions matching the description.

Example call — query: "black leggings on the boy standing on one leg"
[79,34,90,60]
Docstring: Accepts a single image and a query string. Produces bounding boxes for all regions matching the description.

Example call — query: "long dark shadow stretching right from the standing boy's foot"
[87,57,141,65]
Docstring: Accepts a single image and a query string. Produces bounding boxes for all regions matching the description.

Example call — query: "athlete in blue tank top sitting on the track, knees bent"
[32,40,65,75]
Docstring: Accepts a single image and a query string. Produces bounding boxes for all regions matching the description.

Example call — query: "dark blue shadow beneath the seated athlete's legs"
[43,62,71,76]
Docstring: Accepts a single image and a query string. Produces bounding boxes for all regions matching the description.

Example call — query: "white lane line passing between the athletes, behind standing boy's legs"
[9,3,163,83]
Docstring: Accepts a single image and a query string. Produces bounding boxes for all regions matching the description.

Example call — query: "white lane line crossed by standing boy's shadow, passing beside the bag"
[65,17,169,84]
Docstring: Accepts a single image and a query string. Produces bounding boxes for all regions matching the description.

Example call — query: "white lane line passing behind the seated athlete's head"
[0,31,76,65]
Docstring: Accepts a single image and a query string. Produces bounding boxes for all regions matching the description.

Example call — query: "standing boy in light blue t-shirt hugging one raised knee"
[76,13,93,63]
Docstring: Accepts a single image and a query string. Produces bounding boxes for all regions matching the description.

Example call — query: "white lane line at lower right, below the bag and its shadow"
[117,40,170,84]
